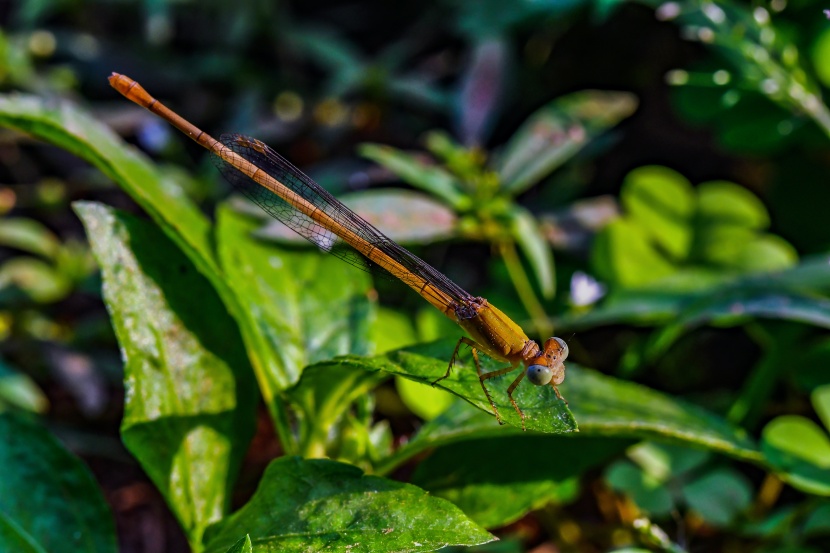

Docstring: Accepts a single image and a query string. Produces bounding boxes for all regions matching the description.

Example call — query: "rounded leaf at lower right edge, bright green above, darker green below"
[761,415,830,496]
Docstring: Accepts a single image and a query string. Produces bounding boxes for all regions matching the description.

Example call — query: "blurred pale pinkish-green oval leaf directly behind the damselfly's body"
[254,189,456,246]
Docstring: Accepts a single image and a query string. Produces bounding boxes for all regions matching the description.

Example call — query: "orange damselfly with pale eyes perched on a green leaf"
[109,73,568,428]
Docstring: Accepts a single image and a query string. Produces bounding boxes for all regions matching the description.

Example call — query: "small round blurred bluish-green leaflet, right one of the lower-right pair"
[683,468,752,526]
